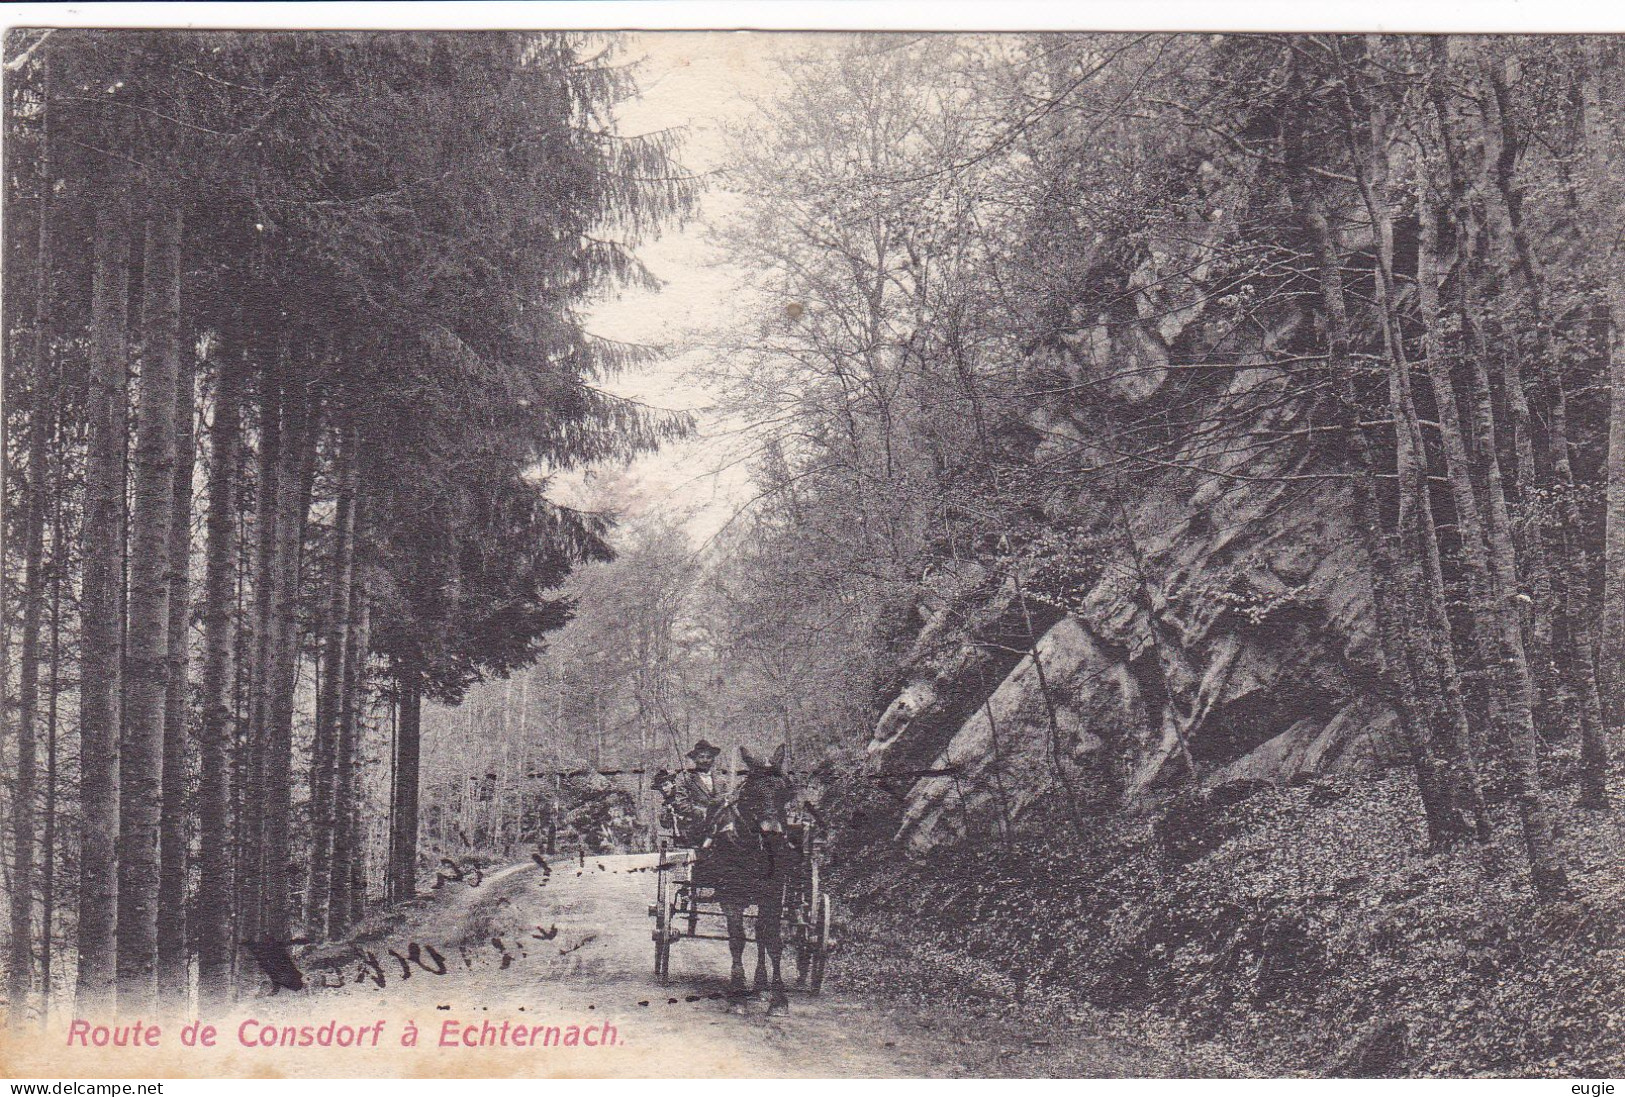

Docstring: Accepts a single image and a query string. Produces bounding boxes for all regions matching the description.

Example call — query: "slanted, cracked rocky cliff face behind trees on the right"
[869,310,1401,852]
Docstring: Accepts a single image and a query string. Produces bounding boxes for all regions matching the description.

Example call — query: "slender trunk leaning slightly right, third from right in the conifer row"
[306,429,356,933]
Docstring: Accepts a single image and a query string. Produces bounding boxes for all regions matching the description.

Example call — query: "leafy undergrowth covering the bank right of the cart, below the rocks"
[834,754,1625,1077]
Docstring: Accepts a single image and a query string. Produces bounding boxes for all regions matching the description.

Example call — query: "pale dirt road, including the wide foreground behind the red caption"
[0,855,1181,1077]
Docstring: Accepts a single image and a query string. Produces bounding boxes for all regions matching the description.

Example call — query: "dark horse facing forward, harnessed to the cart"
[697,746,801,1016]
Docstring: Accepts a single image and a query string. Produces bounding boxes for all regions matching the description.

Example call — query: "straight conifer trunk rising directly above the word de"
[193,348,242,1004]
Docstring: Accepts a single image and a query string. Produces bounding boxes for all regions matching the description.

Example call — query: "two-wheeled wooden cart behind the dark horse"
[648,824,835,995]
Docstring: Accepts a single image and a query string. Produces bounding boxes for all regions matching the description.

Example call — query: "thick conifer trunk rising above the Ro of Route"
[78,198,130,1017]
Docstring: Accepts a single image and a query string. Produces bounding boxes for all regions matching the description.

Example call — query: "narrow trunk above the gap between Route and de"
[158,321,197,1011]
